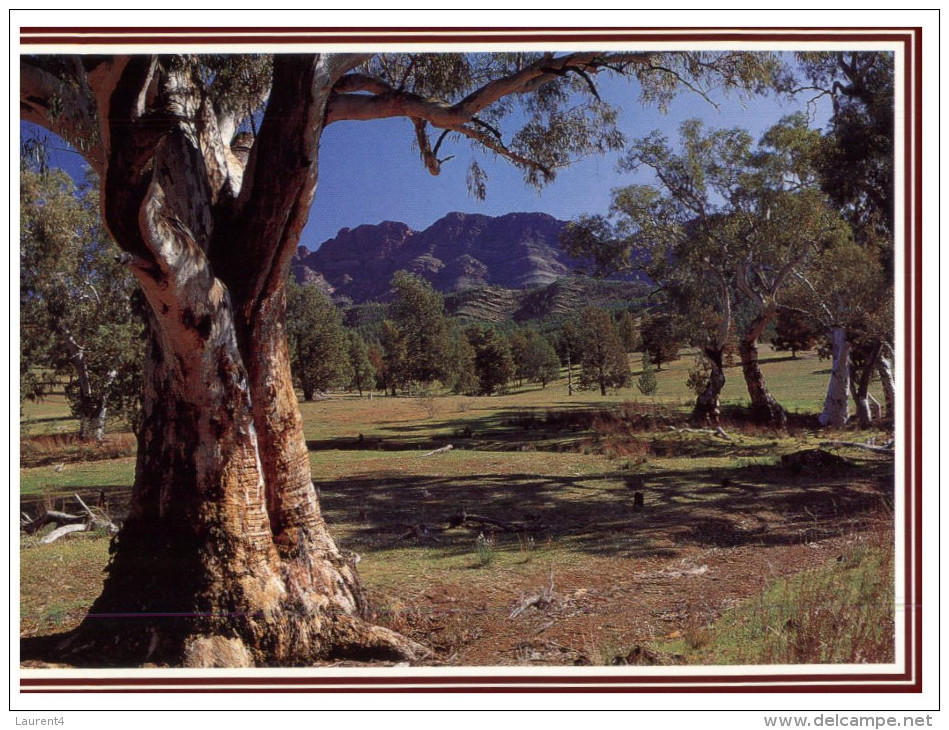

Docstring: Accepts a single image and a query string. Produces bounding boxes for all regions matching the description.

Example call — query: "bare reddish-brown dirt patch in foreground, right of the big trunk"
[344,456,892,666]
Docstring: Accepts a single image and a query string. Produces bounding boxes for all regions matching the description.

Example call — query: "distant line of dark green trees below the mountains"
[287,271,682,400]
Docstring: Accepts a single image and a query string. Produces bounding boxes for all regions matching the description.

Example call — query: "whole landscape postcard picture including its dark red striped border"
[10,15,935,696]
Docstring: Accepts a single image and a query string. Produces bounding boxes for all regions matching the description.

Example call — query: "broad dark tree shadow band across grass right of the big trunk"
[317,450,893,557]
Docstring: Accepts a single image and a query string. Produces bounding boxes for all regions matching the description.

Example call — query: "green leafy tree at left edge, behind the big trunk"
[20,165,144,438]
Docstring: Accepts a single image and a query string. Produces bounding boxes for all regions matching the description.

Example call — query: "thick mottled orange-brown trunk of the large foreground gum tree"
[57,52,422,667]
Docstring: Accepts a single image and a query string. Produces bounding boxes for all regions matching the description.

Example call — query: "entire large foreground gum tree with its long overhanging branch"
[20,52,780,667]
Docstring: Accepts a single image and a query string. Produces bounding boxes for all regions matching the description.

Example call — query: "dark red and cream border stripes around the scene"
[14,27,923,693]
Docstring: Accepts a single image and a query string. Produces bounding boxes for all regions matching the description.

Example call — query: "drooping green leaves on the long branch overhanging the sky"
[352,52,790,193]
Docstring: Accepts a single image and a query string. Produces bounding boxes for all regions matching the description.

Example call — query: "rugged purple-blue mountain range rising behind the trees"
[293,213,642,320]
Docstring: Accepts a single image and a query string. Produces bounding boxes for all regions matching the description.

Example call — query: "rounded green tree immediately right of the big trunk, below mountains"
[287,281,352,400]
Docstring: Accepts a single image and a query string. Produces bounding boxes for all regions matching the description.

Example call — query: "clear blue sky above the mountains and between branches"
[22,57,830,250]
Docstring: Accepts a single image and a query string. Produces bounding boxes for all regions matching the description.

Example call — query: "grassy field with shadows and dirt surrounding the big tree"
[20,351,893,665]
